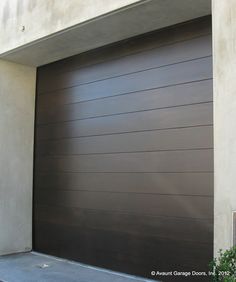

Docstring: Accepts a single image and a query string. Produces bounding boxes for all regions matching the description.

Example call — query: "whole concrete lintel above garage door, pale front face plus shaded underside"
[0,0,211,66]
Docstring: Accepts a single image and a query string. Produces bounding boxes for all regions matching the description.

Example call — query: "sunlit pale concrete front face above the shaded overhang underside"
[0,0,140,53]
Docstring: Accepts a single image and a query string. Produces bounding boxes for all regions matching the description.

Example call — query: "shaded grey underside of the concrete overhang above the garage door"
[0,0,211,66]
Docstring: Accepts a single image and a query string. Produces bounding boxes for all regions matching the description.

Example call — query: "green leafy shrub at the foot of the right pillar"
[210,246,236,282]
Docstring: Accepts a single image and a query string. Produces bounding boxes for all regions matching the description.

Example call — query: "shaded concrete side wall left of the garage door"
[0,60,36,255]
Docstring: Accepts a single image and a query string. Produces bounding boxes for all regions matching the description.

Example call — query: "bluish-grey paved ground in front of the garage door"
[0,253,151,282]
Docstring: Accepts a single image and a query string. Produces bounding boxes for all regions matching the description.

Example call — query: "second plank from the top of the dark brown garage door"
[38,35,211,93]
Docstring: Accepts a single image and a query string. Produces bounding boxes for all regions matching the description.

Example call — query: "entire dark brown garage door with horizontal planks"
[34,18,213,281]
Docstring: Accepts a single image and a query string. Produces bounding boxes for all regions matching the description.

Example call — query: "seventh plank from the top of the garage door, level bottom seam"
[36,149,213,172]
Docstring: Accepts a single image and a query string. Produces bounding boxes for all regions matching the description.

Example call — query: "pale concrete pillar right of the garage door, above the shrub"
[212,0,236,253]
